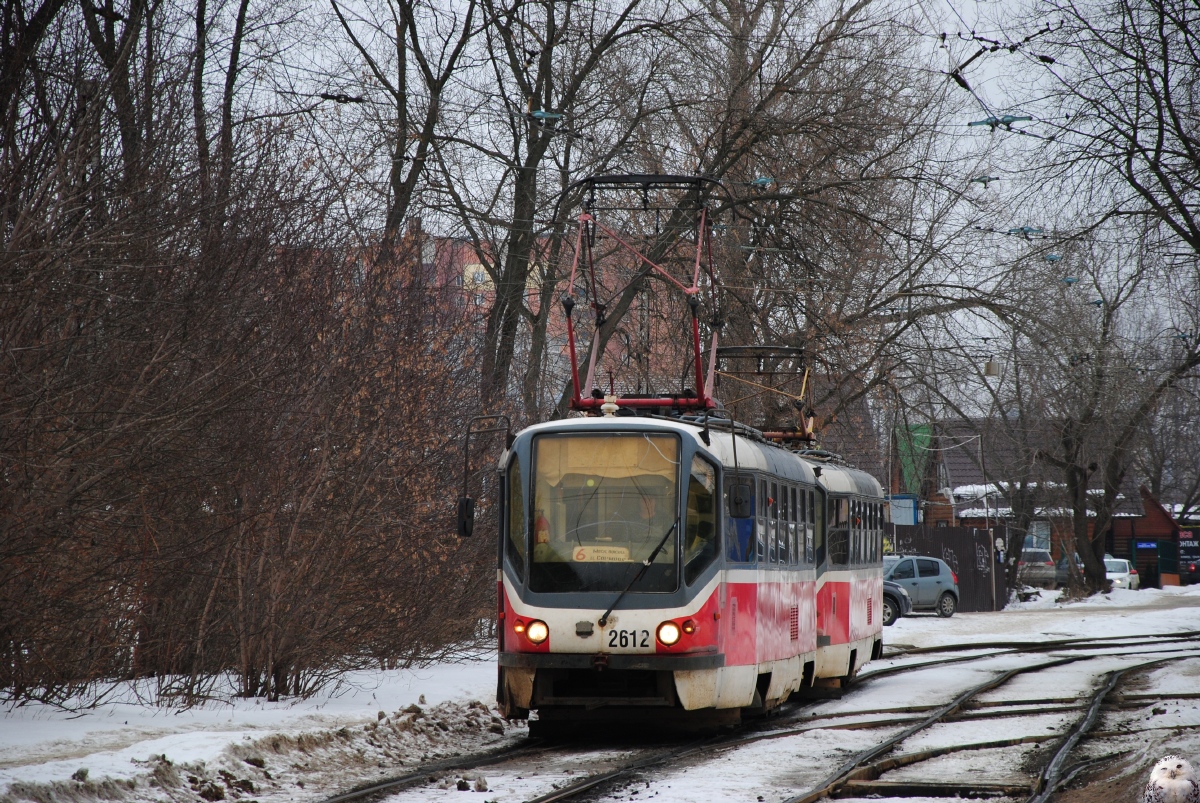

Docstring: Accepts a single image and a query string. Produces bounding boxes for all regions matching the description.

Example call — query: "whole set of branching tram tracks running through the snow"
[323,631,1200,803]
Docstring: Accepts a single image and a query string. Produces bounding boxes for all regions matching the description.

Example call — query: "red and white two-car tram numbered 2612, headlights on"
[497,414,886,724]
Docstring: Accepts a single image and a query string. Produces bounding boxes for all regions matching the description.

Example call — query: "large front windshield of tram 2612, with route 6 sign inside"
[529,433,679,592]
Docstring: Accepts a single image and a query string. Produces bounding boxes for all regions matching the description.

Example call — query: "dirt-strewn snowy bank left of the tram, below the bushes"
[0,660,526,803]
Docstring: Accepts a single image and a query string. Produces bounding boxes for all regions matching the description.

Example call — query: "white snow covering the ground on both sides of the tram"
[0,587,1200,803]
